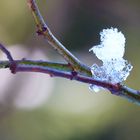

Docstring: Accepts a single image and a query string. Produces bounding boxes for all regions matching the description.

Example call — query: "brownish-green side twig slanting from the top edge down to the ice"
[28,0,92,76]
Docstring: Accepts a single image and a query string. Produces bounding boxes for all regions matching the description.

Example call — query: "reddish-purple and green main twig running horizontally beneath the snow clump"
[0,60,140,105]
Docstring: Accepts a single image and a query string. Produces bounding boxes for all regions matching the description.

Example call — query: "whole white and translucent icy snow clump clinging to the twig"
[89,28,133,92]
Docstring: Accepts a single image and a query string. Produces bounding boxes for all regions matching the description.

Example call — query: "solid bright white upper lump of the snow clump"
[90,28,125,61]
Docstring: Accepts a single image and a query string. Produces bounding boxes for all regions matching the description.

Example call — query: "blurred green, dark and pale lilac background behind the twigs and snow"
[0,0,140,140]
